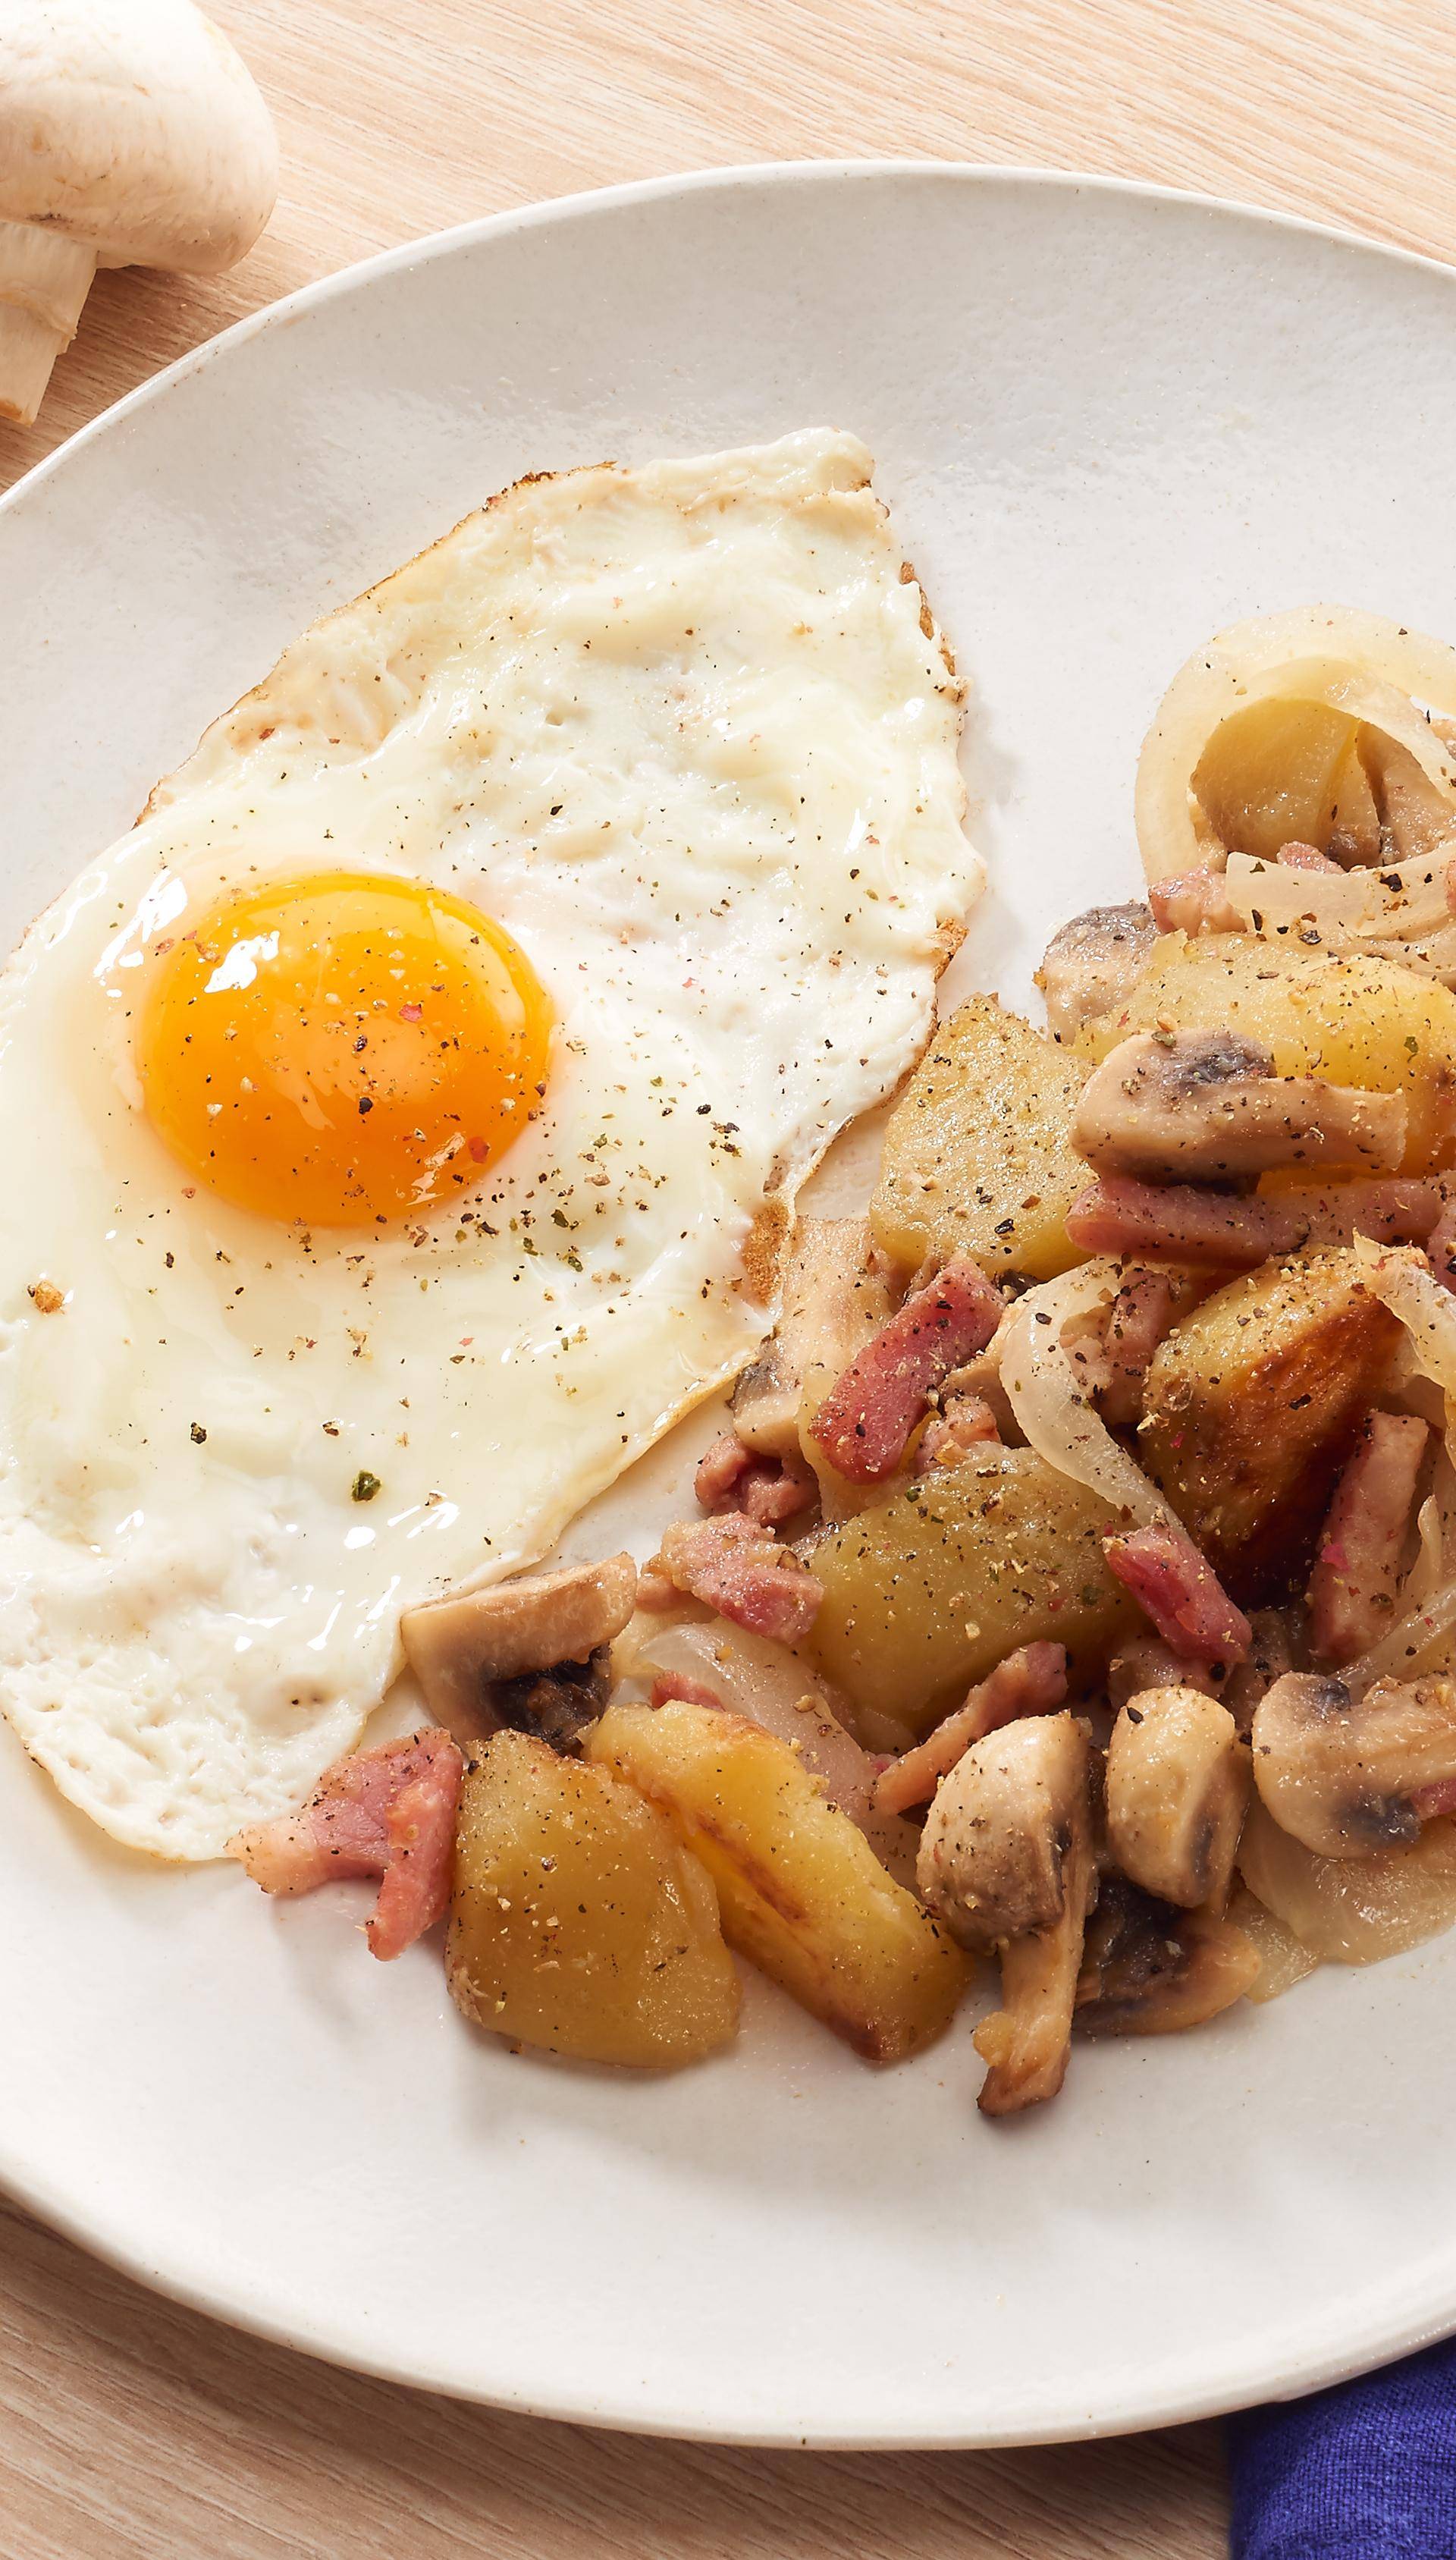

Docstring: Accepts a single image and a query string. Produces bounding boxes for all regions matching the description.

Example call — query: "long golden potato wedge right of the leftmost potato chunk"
[588,1700,968,2063]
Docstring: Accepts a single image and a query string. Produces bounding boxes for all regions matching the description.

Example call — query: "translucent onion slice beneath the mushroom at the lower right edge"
[1238,1802,1456,1964]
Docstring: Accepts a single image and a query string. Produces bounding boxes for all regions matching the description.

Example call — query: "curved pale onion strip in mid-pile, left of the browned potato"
[990,1255,1177,1528]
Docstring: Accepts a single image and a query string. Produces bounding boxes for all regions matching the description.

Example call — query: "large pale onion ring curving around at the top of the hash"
[1136,605,1456,881]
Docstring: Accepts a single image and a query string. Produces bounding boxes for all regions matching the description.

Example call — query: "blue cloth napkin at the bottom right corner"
[1228,2340,1456,2560]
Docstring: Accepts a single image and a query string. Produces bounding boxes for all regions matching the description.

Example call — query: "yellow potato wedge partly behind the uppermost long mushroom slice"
[1078,934,1456,1173]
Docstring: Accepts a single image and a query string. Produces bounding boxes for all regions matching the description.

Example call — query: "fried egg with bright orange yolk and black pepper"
[0,430,980,1858]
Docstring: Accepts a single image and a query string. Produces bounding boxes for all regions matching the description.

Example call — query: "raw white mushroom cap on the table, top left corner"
[0,0,279,277]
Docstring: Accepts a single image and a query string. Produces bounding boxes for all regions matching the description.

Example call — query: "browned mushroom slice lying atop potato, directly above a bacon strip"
[1072,1032,1405,1183]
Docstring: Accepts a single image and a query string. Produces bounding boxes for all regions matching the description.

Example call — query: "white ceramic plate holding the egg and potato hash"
[0,164,1456,2445]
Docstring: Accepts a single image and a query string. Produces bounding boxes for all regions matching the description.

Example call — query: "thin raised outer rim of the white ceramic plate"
[0,156,1456,2452]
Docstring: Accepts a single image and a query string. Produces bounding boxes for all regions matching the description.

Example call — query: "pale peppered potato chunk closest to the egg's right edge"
[870,996,1090,1280]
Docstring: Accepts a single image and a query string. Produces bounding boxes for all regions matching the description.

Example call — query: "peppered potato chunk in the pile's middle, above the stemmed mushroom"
[806,1441,1136,1733]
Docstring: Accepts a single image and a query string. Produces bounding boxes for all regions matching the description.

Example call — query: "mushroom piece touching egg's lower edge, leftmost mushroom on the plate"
[399,1554,637,1748]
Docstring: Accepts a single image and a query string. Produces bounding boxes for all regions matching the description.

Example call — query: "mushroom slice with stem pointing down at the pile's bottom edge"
[916,1713,1098,2115]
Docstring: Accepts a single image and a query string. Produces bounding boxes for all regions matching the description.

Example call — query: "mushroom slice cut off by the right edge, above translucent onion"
[1254,1672,1456,1858]
